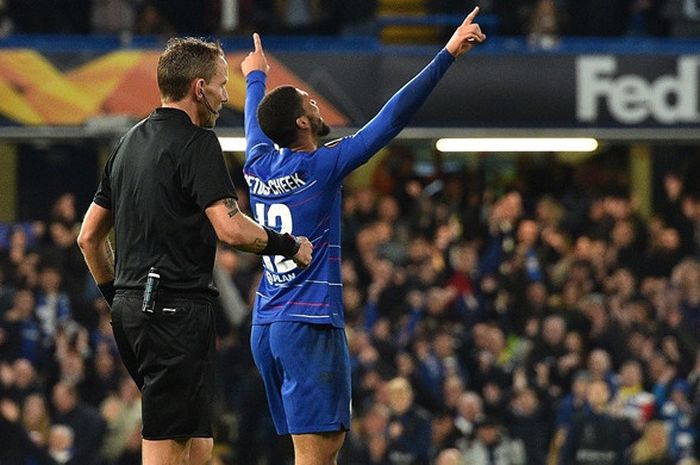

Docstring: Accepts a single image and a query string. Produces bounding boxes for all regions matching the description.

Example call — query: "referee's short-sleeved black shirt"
[94,108,237,291]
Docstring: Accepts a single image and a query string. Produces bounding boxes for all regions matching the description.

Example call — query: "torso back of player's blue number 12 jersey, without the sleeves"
[244,145,343,327]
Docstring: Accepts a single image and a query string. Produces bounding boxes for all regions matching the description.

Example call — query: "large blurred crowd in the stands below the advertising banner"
[0,145,700,465]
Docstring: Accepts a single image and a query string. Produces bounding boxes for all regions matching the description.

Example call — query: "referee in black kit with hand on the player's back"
[78,38,312,465]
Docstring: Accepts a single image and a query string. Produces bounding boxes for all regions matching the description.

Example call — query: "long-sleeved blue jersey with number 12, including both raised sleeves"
[243,49,454,327]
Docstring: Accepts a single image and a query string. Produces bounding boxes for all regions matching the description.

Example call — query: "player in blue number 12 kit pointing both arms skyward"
[241,7,486,465]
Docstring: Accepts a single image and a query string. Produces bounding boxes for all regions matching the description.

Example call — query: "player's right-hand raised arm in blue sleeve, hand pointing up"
[341,7,486,174]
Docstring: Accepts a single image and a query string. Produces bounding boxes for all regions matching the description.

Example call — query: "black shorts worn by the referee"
[112,291,215,440]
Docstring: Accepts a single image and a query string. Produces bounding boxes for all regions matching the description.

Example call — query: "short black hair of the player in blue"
[257,86,304,147]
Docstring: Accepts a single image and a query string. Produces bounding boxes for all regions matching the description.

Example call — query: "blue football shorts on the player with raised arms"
[250,321,350,435]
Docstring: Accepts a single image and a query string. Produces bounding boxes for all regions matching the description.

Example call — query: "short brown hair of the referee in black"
[158,37,224,101]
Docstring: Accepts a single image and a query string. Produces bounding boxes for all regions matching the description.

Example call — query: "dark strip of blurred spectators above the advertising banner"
[0,0,700,40]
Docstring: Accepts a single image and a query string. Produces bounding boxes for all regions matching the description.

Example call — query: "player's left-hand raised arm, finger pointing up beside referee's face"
[241,33,272,156]
